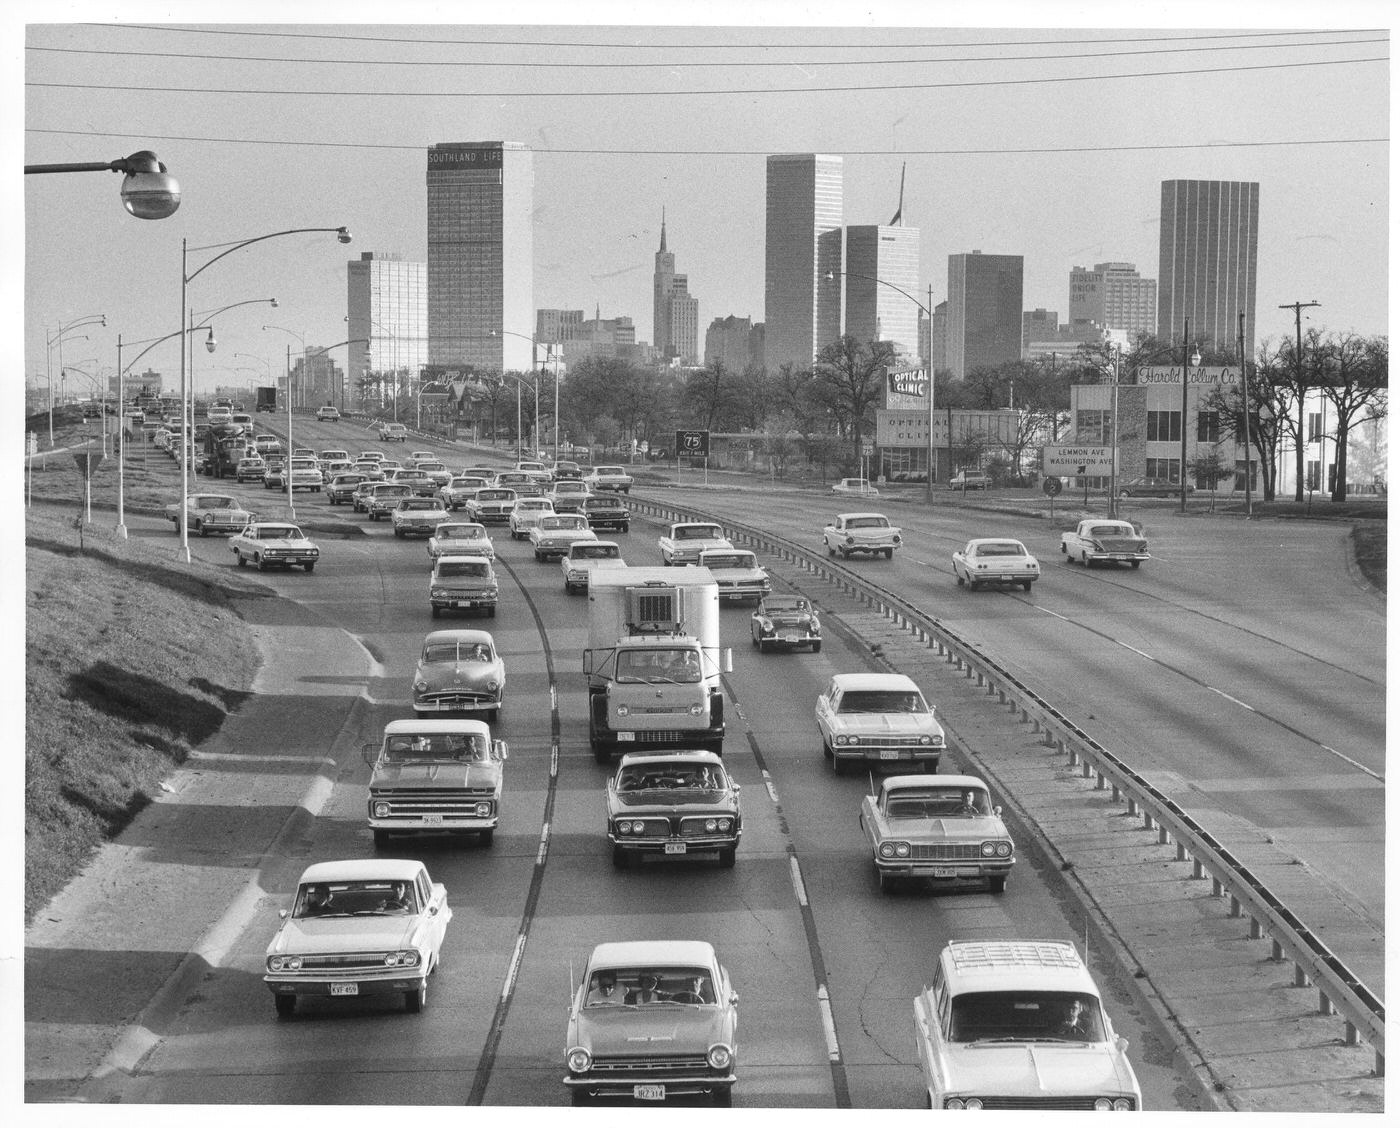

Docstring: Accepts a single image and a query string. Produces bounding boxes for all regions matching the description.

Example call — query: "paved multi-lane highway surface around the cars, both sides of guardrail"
[27,424,1385,1108]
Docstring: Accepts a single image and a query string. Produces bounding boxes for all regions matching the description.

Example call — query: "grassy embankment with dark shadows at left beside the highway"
[24,504,266,921]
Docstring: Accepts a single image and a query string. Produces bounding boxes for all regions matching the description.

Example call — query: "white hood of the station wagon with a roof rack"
[948,1043,1137,1096]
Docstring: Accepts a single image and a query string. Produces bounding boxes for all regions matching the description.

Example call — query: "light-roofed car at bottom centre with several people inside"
[563,940,739,1107]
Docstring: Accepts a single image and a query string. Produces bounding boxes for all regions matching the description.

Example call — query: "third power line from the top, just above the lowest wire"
[25,56,1390,98]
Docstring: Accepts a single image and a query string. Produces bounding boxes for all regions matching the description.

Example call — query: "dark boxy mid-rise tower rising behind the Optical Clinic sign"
[946,251,1022,379]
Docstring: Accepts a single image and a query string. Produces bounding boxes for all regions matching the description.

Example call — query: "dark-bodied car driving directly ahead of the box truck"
[608,749,743,869]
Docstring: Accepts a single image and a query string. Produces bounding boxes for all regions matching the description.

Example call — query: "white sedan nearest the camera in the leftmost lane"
[263,858,452,1019]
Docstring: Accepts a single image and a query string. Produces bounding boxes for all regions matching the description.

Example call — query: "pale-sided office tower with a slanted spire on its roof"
[846,224,921,360]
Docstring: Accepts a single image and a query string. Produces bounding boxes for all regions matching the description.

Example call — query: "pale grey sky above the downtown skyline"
[4,0,1390,403]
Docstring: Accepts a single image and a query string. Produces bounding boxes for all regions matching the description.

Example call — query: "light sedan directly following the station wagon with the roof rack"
[860,775,1016,893]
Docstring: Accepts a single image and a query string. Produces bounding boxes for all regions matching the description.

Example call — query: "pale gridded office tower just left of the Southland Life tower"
[346,251,428,406]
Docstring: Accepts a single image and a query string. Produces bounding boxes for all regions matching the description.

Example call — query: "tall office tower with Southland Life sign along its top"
[427,141,535,371]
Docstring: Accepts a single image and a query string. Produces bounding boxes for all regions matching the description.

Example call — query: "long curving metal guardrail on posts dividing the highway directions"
[630,495,1386,1076]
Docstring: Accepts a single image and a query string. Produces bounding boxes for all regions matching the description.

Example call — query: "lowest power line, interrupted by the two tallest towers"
[25,127,1390,157]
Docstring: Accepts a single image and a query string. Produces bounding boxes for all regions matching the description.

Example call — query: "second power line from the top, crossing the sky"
[25,36,1390,70]
